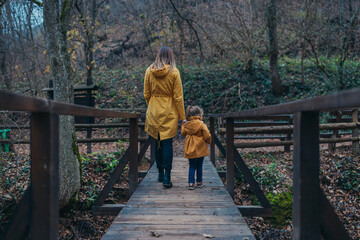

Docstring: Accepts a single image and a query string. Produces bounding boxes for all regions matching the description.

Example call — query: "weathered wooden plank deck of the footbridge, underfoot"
[103,158,255,240]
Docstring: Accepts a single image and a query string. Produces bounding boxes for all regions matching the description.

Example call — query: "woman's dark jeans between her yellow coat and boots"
[155,138,173,170]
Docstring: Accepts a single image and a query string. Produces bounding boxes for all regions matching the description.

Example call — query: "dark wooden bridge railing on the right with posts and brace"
[210,90,360,239]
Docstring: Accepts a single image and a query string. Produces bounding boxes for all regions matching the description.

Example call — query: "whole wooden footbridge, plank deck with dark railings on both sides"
[0,90,360,240]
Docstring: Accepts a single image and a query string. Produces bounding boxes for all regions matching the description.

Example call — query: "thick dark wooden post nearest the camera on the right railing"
[293,112,320,240]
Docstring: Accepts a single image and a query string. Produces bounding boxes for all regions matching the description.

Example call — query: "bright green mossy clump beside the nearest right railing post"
[266,187,292,228]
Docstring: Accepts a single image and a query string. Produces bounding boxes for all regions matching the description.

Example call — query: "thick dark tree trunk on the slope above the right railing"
[266,0,284,95]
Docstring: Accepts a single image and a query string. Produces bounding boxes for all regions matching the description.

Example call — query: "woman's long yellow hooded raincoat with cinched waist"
[144,65,185,140]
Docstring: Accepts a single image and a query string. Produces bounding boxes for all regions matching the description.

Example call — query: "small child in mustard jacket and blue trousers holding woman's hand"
[181,106,211,190]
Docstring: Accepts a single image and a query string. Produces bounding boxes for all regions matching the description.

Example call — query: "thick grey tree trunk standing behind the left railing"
[43,0,80,206]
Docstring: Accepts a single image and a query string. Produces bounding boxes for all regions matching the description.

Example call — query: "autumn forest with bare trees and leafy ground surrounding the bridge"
[0,0,360,239]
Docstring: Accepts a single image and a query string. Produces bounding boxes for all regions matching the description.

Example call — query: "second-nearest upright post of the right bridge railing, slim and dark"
[226,118,235,197]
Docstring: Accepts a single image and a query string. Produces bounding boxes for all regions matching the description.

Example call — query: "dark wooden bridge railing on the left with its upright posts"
[0,90,143,239]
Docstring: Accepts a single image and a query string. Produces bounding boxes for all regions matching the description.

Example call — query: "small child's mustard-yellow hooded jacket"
[181,116,211,159]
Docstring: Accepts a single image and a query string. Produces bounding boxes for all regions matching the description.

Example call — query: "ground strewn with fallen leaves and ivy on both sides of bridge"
[0,142,360,239]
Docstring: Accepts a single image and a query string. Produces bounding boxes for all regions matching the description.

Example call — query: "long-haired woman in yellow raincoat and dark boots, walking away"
[144,47,185,188]
